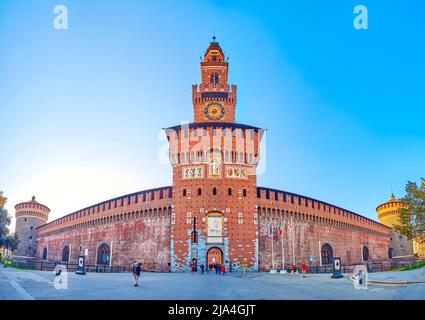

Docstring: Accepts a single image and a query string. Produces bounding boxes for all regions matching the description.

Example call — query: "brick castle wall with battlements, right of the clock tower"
[257,188,391,270]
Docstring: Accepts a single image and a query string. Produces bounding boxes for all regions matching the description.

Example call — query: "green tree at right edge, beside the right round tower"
[395,178,425,243]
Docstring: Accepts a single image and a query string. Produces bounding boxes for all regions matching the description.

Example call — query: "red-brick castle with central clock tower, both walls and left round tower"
[16,38,391,272]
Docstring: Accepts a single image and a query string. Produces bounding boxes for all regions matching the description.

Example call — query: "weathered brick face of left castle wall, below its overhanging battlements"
[37,212,170,271]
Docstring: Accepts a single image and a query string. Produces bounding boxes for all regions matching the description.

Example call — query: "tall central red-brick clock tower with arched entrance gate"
[165,37,264,271]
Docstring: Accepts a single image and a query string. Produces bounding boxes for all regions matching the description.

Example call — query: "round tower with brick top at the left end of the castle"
[15,196,50,257]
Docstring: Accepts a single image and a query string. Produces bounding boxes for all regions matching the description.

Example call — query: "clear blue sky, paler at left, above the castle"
[0,0,425,229]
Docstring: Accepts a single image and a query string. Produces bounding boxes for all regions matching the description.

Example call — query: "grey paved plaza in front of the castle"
[0,268,425,300]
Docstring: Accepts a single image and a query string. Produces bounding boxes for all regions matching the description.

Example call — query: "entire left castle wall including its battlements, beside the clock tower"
[36,187,172,271]
